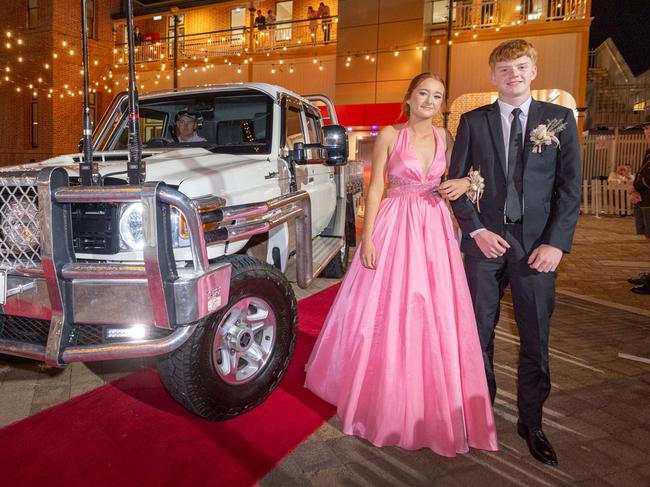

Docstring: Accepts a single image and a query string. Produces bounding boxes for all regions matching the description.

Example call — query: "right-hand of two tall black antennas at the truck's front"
[126,0,146,186]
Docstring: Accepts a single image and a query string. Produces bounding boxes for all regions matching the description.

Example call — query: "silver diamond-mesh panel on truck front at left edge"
[0,176,40,270]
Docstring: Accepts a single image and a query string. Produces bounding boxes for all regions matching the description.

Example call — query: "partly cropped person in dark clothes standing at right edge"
[628,115,650,294]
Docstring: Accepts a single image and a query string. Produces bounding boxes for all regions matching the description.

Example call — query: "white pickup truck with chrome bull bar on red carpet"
[0,83,362,420]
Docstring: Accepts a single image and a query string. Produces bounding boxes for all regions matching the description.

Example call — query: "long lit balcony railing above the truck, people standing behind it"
[113,17,338,65]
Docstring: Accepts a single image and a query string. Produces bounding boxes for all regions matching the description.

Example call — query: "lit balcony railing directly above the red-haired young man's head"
[432,0,588,30]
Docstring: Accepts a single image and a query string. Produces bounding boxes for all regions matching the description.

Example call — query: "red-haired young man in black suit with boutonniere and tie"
[449,39,581,465]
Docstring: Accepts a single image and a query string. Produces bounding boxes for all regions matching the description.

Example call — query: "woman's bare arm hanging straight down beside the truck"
[361,126,396,269]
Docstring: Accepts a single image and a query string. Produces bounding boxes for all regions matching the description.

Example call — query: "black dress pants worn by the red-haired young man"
[465,224,556,427]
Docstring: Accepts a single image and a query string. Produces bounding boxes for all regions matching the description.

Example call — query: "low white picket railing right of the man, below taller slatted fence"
[581,179,634,216]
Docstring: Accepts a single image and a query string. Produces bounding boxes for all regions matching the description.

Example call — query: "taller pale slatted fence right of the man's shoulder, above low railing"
[582,134,650,180]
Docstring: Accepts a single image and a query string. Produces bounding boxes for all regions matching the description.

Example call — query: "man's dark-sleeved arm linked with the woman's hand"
[447,115,484,235]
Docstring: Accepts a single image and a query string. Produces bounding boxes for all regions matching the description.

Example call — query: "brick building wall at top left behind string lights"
[0,0,113,166]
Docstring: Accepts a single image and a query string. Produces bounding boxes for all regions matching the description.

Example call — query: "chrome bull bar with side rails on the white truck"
[0,168,313,366]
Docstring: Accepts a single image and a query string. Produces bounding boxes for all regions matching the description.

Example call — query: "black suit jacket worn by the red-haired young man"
[449,100,582,258]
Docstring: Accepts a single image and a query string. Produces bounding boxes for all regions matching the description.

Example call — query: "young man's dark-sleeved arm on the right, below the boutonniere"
[542,110,582,252]
